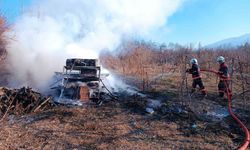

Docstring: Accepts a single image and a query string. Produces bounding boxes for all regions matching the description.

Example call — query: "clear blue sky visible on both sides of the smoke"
[0,0,250,45]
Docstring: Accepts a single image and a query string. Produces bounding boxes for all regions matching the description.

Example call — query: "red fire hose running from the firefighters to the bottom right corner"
[201,69,250,150]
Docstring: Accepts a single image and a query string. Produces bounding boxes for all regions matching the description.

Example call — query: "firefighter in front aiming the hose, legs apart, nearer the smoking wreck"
[186,58,207,96]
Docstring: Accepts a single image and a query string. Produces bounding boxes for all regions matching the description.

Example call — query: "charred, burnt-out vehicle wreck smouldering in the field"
[55,58,101,102]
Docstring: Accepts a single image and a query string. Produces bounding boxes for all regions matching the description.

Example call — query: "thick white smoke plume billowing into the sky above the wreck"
[8,0,183,89]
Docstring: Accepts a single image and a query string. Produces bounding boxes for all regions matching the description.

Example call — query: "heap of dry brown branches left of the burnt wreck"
[0,87,55,118]
